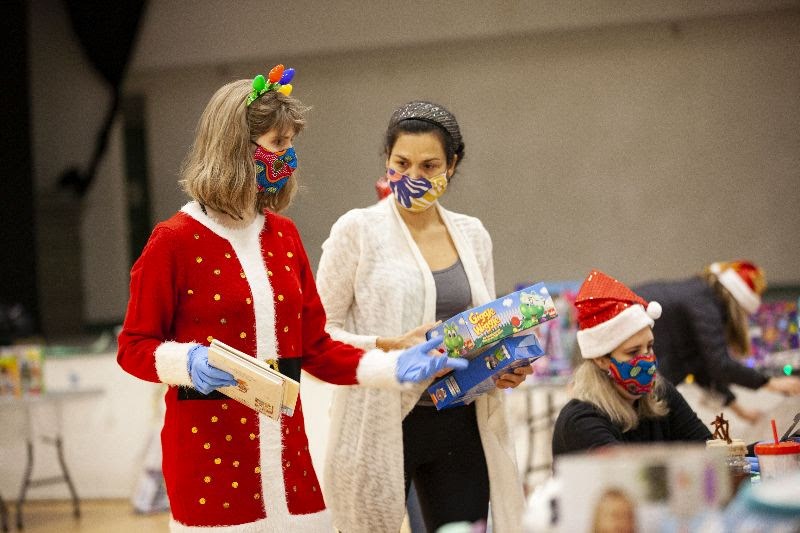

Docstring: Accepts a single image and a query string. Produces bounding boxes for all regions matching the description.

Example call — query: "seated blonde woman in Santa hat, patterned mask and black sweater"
[553,270,711,457]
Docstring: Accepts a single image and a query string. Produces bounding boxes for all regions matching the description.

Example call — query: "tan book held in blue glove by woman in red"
[208,339,300,420]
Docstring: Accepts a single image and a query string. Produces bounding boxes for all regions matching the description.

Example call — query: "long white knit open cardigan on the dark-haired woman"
[317,195,525,533]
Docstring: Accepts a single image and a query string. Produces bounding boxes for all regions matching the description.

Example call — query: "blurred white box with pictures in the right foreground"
[544,442,732,533]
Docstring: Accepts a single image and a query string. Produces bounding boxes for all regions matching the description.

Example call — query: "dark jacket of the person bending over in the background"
[634,277,768,405]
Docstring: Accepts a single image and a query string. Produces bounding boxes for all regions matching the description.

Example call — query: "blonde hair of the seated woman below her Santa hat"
[572,356,669,433]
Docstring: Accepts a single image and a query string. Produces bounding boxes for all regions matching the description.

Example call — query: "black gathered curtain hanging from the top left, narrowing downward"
[59,0,146,196]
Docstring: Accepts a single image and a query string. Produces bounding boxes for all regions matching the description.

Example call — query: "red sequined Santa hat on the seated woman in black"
[575,270,661,359]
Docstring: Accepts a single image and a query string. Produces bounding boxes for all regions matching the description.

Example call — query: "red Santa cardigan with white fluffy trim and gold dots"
[117,203,396,531]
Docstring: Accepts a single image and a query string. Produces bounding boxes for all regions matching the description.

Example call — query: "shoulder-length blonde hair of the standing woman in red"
[179,80,309,218]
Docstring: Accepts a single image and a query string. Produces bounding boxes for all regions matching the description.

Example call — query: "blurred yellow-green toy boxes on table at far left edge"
[0,344,44,397]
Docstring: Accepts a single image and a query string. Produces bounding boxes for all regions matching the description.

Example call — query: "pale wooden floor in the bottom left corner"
[9,500,169,533]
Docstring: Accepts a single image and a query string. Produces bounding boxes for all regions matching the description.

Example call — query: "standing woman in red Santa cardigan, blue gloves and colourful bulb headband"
[117,65,465,532]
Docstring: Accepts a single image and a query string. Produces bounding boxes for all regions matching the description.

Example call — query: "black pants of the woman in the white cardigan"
[403,403,489,533]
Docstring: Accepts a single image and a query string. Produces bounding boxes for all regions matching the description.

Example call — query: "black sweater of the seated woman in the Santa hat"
[553,382,711,457]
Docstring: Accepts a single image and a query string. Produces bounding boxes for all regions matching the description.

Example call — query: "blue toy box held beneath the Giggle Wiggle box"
[428,333,544,410]
